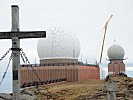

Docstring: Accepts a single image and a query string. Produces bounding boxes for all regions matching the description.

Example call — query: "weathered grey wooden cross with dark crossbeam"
[0,5,46,100]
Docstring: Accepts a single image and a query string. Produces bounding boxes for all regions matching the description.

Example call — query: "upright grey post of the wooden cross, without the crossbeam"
[12,5,20,100]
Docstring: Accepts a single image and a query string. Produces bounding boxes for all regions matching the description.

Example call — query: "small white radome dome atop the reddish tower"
[107,44,125,60]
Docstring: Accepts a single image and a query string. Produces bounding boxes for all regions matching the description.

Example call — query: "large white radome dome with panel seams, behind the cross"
[37,27,80,60]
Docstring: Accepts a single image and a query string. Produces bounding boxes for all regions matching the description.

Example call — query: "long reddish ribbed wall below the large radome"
[20,65,100,86]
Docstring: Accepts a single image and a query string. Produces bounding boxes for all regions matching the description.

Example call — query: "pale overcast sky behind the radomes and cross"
[0,0,133,63]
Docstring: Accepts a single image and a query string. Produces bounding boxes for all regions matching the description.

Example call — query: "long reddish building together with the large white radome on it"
[20,28,100,86]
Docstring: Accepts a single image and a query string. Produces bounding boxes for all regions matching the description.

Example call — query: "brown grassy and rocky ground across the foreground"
[0,75,133,100]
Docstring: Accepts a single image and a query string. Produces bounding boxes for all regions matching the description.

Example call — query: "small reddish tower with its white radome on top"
[107,44,125,75]
